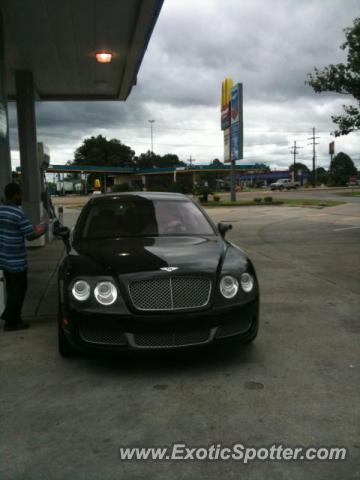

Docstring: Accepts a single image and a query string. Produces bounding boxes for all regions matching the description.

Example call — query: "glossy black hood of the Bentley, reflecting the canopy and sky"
[71,236,226,274]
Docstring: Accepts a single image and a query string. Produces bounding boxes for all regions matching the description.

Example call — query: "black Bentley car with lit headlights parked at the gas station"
[58,192,259,356]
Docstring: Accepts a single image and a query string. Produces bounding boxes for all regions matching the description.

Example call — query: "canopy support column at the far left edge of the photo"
[0,11,12,199]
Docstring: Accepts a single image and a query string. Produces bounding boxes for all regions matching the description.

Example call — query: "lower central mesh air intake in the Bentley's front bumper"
[134,329,210,348]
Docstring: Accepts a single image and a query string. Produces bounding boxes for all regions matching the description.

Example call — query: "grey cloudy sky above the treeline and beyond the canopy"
[10,0,360,168]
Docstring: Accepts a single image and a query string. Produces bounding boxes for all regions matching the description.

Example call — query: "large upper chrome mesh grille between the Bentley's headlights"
[129,277,211,311]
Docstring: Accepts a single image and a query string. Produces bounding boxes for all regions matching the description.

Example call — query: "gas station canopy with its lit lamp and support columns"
[0,0,163,240]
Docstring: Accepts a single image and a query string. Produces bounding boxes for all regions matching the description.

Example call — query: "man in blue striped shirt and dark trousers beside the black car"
[0,183,47,332]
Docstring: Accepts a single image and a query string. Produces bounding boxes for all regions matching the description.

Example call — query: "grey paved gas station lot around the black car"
[0,203,360,480]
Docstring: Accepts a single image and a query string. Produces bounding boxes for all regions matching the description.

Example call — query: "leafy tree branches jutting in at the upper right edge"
[306,17,360,137]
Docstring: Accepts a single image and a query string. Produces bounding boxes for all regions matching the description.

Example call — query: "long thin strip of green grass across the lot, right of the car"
[201,198,345,207]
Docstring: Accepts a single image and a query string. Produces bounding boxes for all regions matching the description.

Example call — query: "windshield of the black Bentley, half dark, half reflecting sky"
[82,197,215,240]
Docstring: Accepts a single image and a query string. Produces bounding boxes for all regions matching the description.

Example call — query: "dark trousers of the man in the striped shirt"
[1,270,27,325]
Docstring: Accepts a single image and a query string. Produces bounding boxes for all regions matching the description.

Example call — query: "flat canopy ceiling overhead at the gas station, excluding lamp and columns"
[0,0,163,101]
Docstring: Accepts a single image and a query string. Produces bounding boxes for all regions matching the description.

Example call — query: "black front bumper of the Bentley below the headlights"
[59,298,259,352]
